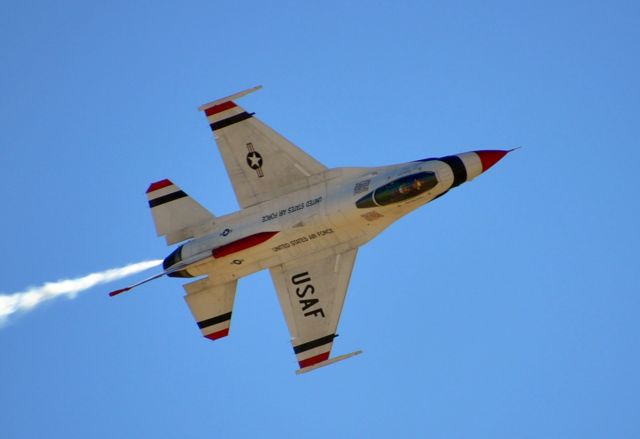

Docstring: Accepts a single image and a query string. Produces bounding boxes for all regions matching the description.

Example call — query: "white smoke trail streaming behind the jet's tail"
[0,259,162,323]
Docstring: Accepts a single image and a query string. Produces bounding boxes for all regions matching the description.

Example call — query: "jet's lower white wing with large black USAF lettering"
[271,249,360,373]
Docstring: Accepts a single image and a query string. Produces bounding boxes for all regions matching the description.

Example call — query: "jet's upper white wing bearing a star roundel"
[199,86,327,209]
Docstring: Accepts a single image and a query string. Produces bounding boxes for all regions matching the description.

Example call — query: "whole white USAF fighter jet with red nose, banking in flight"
[110,87,509,373]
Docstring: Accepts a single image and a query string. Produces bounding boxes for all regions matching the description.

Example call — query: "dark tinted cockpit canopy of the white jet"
[356,172,438,209]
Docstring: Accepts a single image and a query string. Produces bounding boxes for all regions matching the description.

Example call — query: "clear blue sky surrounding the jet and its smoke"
[0,1,640,439]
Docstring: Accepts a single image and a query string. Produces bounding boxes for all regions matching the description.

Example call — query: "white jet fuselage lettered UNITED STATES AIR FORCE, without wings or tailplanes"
[170,153,482,284]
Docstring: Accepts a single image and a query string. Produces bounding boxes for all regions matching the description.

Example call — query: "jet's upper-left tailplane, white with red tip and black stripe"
[147,180,215,245]
